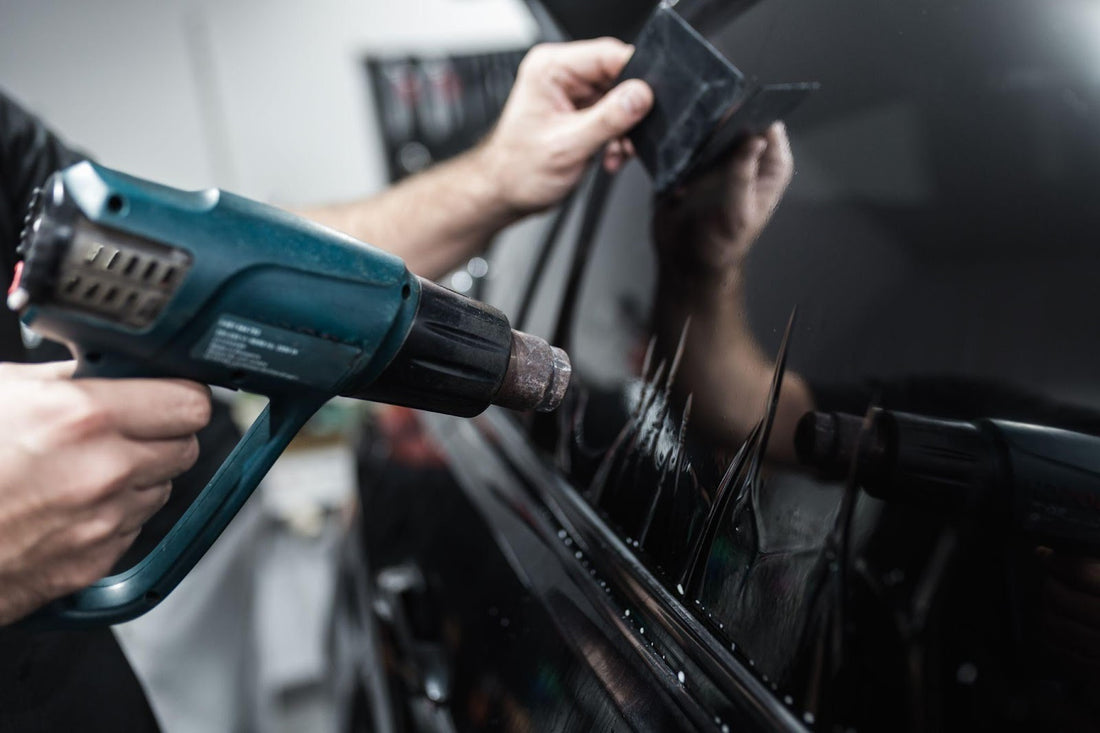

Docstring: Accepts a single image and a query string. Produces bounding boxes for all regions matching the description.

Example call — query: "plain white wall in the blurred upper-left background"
[0,0,536,204]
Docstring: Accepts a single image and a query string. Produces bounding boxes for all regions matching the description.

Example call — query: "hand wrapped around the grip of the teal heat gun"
[0,362,210,625]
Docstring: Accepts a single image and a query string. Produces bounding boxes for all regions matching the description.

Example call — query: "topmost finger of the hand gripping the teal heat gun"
[74,379,211,439]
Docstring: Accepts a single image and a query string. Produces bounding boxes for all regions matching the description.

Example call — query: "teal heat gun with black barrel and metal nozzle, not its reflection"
[8,163,570,627]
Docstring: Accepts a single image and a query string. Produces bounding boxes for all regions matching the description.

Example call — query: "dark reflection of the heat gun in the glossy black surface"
[795,409,1100,554]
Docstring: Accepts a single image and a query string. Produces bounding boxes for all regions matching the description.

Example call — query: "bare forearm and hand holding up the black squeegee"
[299,39,653,278]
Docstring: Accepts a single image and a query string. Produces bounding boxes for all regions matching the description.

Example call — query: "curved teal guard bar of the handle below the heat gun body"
[21,396,326,628]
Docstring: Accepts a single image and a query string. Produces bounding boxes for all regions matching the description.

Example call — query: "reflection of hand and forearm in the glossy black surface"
[653,123,813,461]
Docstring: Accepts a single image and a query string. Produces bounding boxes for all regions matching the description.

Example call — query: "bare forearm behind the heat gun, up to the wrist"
[299,147,519,280]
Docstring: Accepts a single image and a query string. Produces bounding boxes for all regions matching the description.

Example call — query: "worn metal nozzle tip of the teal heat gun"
[493,331,573,413]
